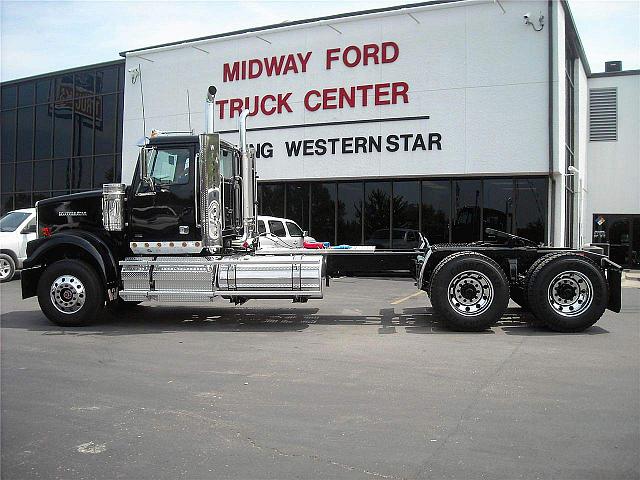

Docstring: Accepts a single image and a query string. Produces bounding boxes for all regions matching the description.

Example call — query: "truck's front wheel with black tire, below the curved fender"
[38,260,104,327]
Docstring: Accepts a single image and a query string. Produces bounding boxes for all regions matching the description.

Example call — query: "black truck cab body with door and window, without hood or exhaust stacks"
[125,133,243,254]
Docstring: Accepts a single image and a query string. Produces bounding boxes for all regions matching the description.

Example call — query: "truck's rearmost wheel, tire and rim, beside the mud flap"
[528,254,609,332]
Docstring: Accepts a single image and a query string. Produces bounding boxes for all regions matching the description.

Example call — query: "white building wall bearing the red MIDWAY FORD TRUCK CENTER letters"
[122,1,552,186]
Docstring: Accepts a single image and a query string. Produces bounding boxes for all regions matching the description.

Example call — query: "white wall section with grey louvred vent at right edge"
[583,74,640,242]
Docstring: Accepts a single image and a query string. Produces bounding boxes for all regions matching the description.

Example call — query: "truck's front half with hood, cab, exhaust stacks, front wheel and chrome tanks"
[22,90,325,326]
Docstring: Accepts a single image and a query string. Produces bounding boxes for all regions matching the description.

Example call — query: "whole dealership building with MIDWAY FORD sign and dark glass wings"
[1,0,640,267]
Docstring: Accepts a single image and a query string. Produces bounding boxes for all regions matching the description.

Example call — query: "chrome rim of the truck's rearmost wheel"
[548,270,593,317]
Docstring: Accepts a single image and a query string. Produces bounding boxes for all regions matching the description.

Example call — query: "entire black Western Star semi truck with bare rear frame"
[22,87,621,332]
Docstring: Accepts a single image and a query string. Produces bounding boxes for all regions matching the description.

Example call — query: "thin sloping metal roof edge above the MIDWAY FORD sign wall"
[120,0,467,57]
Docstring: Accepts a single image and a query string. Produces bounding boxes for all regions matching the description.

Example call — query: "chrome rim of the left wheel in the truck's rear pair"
[448,270,494,317]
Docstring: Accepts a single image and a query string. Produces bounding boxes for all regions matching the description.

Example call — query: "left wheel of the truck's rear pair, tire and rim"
[429,252,509,332]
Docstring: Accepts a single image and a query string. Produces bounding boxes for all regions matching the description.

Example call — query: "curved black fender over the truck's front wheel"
[21,230,118,298]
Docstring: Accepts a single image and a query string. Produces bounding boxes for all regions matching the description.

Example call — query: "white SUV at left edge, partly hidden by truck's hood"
[0,208,38,282]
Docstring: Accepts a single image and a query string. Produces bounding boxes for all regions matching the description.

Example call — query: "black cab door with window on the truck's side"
[129,145,199,244]
